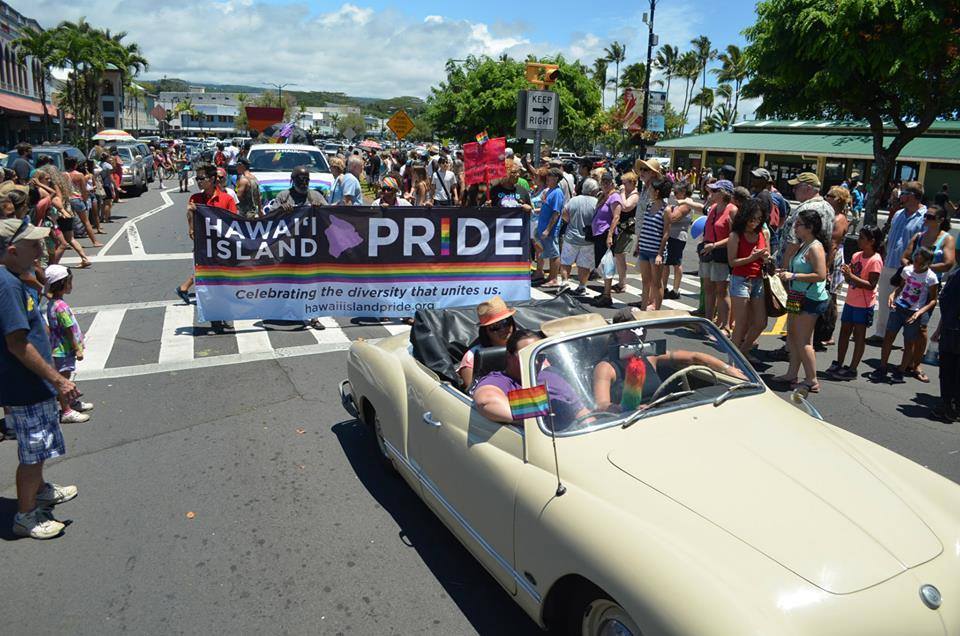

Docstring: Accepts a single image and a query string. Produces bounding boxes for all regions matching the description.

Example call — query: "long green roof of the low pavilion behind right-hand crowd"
[656,131,960,163]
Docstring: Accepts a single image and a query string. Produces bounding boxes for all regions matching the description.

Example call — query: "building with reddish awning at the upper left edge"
[0,0,59,148]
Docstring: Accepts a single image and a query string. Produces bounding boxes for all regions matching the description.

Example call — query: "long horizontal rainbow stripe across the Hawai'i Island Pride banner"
[195,260,530,285]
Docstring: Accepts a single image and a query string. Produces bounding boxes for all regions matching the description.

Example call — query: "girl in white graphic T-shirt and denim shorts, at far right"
[867,247,939,384]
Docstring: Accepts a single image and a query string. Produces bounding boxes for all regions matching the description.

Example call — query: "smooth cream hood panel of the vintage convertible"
[607,404,943,594]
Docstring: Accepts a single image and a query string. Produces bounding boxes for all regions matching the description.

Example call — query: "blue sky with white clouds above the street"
[18,0,754,111]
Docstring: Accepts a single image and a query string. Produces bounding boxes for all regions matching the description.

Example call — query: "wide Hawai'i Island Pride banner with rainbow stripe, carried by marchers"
[194,206,530,321]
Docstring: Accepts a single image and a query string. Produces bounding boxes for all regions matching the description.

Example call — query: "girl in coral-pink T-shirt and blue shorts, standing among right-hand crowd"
[827,225,883,380]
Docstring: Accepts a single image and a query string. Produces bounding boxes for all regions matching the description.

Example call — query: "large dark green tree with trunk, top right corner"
[744,0,960,222]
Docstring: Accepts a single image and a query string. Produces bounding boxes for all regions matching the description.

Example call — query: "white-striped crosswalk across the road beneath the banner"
[74,272,712,380]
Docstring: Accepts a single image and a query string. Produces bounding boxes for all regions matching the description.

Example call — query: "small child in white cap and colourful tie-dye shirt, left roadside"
[45,265,93,424]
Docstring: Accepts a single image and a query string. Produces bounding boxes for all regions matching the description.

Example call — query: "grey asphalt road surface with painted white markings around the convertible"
[0,179,960,634]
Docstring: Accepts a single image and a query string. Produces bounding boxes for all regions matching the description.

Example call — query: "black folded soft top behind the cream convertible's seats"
[410,294,591,386]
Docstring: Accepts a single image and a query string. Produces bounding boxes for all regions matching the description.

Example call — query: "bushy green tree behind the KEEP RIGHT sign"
[426,56,600,148]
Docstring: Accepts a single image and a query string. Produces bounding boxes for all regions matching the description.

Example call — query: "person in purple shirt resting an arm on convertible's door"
[473,329,589,429]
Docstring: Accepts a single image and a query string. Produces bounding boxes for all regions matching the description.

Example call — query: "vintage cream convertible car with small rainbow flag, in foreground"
[341,297,960,636]
